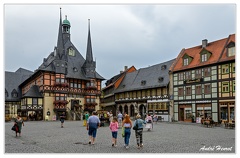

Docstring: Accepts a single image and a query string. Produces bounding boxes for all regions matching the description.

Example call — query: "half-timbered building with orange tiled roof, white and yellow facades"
[170,35,235,121]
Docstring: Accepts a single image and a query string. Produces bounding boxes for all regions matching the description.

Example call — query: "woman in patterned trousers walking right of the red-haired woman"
[134,114,146,149]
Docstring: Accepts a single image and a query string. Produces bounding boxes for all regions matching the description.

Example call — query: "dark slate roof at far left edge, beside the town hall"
[5,68,33,101]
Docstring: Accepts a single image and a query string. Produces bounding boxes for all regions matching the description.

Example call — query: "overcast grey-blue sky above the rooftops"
[4,4,236,83]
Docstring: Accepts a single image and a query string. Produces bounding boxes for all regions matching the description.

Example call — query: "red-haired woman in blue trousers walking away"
[122,114,132,149]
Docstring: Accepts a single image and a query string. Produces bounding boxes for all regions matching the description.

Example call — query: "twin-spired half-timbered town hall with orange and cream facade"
[6,9,104,120]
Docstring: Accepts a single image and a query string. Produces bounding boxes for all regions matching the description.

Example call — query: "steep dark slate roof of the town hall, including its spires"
[36,10,105,80]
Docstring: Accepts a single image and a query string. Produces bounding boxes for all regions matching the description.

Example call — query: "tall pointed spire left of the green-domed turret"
[57,8,64,59]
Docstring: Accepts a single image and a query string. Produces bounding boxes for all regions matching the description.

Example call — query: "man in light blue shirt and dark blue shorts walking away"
[87,111,101,145]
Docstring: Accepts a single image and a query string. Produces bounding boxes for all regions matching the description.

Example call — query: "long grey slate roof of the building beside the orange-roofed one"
[114,59,175,93]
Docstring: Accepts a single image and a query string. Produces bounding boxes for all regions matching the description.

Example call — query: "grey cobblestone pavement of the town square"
[5,121,235,154]
